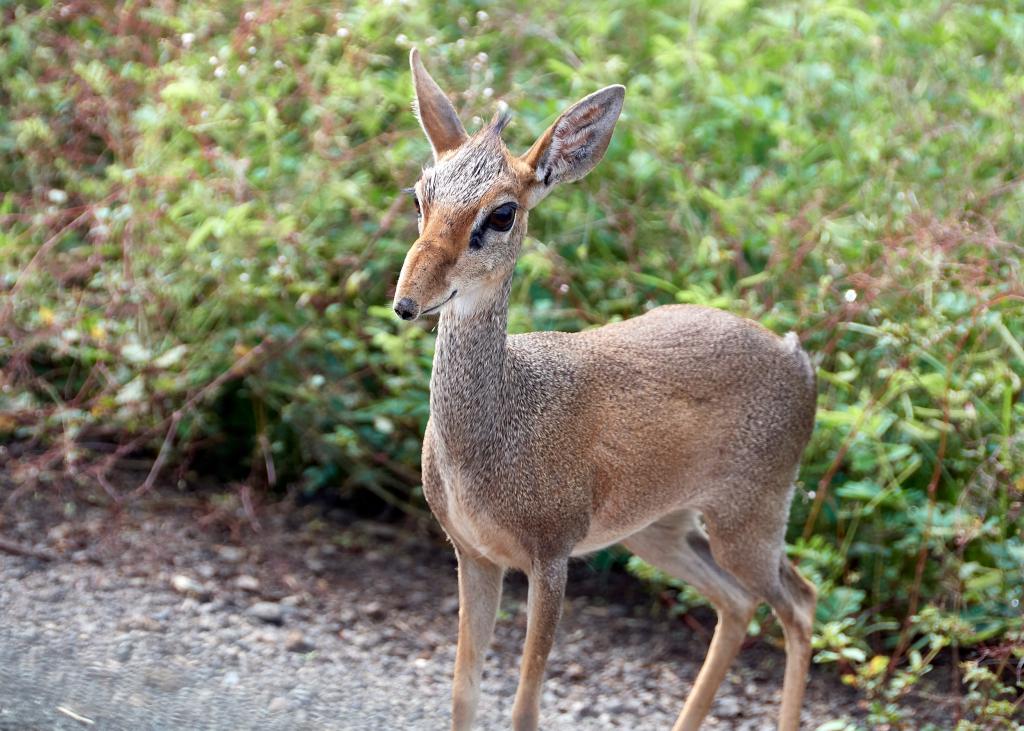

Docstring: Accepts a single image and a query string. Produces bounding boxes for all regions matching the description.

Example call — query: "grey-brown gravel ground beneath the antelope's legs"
[0,487,856,731]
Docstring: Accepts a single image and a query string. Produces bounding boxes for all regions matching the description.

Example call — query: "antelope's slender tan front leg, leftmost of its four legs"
[452,551,505,731]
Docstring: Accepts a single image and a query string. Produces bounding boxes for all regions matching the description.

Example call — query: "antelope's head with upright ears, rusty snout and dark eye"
[394,49,626,319]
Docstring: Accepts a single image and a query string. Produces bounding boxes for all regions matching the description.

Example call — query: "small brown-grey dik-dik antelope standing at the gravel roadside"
[394,50,816,731]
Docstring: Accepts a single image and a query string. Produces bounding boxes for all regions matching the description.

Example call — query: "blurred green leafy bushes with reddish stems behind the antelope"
[0,0,1024,729]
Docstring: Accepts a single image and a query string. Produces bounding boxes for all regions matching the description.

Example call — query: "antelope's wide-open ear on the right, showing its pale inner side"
[521,84,626,207]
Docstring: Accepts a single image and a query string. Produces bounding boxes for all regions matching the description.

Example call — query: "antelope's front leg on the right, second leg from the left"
[512,559,568,731]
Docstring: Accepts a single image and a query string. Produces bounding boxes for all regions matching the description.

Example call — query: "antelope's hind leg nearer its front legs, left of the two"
[624,510,758,731]
